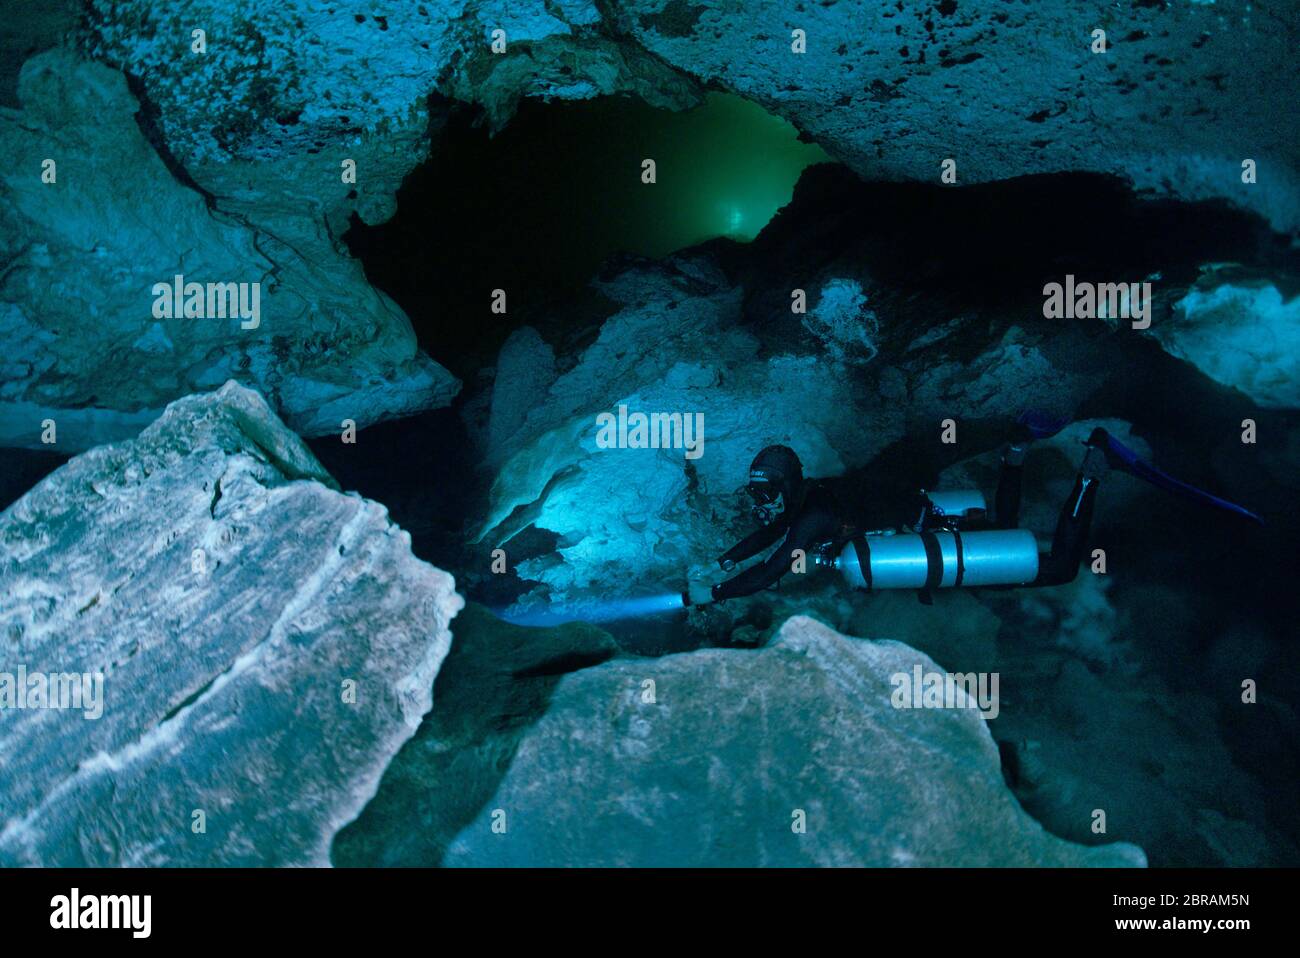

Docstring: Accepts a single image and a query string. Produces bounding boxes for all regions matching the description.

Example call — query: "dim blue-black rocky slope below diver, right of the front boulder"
[842,579,1296,867]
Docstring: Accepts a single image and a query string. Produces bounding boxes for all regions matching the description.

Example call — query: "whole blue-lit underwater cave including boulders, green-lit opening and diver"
[0,3,1300,889]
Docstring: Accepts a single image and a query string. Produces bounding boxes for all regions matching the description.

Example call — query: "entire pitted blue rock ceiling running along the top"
[87,0,1300,230]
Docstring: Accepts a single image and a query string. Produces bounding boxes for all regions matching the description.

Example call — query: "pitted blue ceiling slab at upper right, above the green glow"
[615,0,1300,230]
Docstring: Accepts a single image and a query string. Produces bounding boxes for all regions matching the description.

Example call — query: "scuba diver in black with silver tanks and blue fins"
[683,412,1262,606]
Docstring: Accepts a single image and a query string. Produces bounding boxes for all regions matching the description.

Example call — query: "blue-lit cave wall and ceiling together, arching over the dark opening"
[0,0,1300,450]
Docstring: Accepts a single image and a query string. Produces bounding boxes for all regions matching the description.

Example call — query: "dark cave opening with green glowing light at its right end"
[345,92,829,377]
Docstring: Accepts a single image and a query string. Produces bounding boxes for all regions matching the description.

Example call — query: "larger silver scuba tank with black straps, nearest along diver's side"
[835,529,1039,590]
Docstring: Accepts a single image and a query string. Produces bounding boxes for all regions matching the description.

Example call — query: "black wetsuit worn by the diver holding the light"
[712,422,1100,601]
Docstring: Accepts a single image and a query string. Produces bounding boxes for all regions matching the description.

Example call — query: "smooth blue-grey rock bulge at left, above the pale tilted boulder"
[0,52,459,451]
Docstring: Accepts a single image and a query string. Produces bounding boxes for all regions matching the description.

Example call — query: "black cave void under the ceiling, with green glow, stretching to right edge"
[332,85,1300,613]
